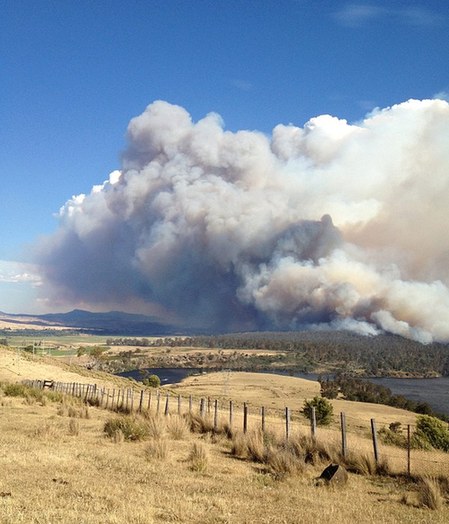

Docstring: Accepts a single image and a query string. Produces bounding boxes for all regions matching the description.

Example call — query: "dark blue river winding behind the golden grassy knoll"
[119,368,449,415]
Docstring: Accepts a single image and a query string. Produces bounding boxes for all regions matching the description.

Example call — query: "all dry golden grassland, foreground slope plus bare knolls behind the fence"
[0,349,449,524]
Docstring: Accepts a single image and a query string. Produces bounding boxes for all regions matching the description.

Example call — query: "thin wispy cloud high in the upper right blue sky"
[334,3,444,27]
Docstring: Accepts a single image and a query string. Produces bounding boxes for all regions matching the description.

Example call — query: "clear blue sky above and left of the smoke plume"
[0,0,449,312]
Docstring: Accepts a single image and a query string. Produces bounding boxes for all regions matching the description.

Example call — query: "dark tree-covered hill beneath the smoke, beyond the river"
[107,331,449,376]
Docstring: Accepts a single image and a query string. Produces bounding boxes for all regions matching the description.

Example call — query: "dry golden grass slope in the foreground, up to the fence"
[0,350,449,524]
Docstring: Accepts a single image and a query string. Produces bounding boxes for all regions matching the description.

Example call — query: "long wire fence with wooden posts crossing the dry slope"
[23,380,449,475]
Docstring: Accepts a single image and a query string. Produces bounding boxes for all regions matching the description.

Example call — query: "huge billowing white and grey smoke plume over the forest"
[37,99,449,342]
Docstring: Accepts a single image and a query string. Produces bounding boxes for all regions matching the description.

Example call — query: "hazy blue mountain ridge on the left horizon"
[0,309,179,336]
